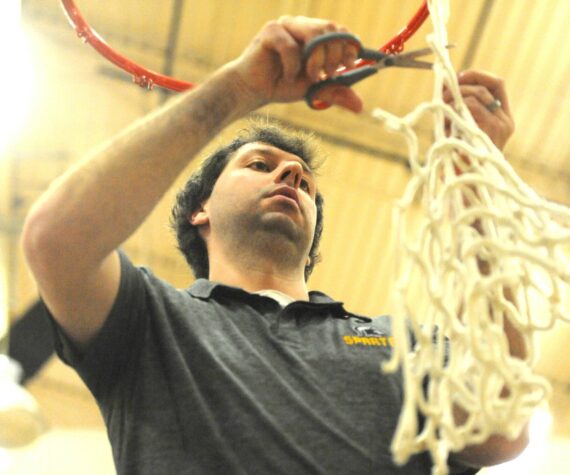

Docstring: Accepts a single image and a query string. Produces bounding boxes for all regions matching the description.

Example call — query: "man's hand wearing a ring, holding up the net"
[443,71,515,150]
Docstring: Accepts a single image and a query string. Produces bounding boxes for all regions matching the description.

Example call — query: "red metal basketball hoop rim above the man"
[61,0,429,92]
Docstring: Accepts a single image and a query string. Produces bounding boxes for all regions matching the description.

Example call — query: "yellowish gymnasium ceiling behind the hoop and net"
[23,0,570,203]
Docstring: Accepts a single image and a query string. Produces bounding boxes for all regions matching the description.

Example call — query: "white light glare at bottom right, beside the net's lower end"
[484,408,552,475]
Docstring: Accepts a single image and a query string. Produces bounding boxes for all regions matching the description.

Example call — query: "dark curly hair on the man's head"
[170,124,324,280]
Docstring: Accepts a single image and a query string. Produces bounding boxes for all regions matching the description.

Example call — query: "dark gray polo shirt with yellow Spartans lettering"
[47,254,476,475]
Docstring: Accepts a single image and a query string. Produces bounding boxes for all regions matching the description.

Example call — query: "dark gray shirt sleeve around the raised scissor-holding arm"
[43,251,148,398]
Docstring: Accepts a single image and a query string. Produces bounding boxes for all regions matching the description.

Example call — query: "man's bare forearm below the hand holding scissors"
[22,68,253,266]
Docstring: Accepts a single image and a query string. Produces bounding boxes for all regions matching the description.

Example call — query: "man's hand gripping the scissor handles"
[224,16,362,112]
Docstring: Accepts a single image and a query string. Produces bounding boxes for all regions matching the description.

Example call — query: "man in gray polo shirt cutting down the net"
[23,17,525,475]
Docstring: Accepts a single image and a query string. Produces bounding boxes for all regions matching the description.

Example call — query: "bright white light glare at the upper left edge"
[0,0,34,153]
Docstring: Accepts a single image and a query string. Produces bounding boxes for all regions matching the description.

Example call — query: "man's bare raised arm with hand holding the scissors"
[22,17,362,346]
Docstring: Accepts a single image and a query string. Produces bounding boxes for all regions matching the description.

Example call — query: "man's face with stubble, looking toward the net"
[197,142,317,259]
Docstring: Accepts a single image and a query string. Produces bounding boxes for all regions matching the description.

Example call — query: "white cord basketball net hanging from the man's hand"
[373,0,570,475]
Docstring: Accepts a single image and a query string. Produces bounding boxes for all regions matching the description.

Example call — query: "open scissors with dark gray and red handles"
[303,32,433,110]
